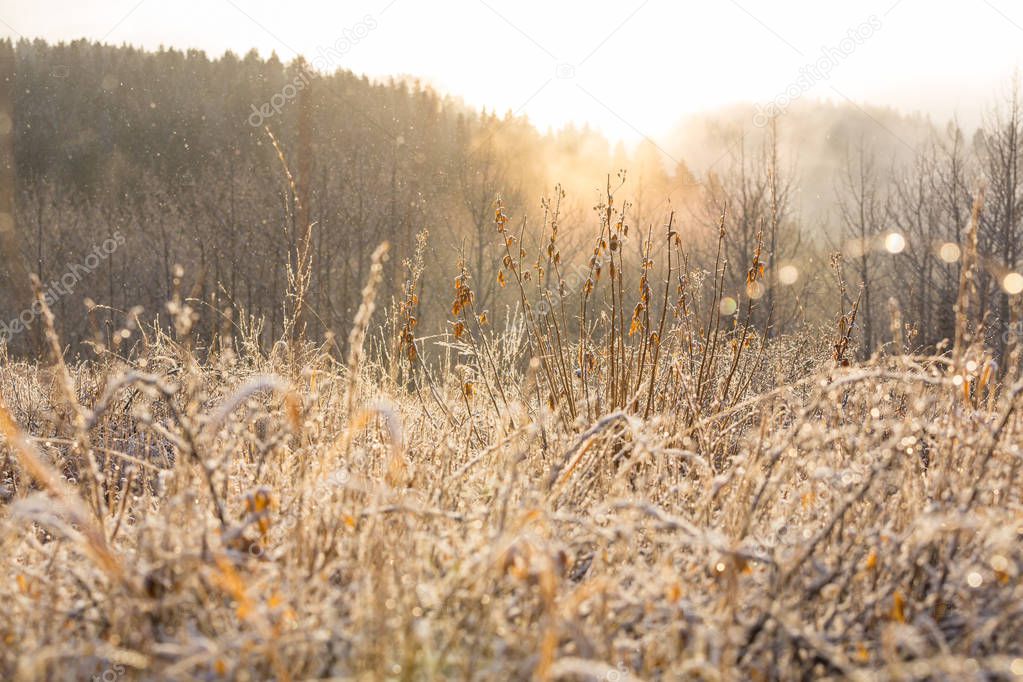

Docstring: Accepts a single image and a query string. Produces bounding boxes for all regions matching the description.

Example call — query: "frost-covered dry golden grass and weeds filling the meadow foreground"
[0,184,1023,681]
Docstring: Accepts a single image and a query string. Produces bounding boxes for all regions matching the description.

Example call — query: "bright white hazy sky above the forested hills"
[0,0,1023,141]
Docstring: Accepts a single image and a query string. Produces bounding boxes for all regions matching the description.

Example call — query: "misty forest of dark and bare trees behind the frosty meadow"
[0,41,1023,368]
